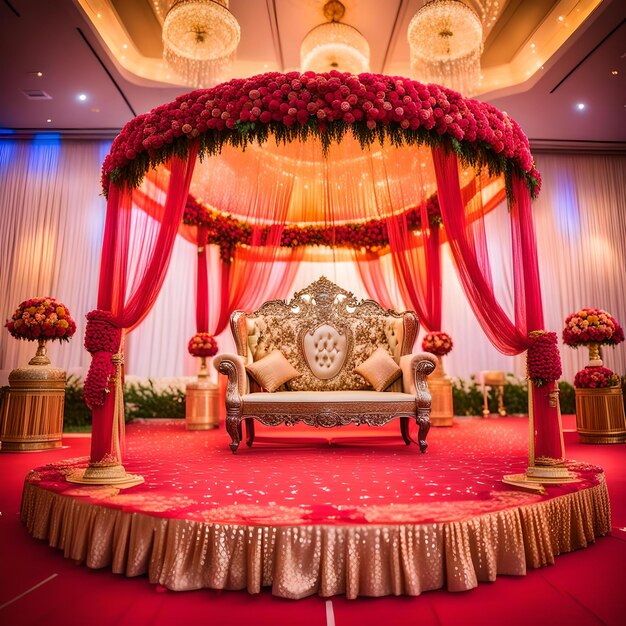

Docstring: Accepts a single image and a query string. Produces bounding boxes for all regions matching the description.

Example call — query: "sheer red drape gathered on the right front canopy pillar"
[433,147,564,459]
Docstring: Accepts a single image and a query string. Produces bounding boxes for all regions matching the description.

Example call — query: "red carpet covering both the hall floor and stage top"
[0,418,626,625]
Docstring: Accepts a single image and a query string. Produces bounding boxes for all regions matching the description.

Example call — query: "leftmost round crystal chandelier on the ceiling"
[163,0,240,87]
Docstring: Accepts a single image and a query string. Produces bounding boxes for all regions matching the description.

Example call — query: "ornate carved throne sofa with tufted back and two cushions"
[213,277,437,452]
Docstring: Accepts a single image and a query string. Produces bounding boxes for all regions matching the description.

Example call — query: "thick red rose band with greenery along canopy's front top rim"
[102,71,541,196]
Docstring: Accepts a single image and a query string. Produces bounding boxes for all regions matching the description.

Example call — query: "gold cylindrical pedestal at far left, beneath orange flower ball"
[0,365,65,451]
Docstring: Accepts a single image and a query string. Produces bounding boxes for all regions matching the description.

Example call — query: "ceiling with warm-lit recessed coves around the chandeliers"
[0,0,626,150]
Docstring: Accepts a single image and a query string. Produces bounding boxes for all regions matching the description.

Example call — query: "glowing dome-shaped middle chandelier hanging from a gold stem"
[300,0,370,74]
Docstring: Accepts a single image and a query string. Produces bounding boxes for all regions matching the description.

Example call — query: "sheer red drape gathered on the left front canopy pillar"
[91,143,198,463]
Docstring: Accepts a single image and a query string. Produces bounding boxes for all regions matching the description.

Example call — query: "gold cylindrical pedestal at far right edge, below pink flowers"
[576,387,626,443]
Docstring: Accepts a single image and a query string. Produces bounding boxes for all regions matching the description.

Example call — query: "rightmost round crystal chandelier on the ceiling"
[408,0,483,96]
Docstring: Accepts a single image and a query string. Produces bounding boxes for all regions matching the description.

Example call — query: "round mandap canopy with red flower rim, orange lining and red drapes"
[86,72,562,478]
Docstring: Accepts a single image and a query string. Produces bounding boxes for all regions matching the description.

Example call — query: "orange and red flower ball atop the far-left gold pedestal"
[5,298,76,341]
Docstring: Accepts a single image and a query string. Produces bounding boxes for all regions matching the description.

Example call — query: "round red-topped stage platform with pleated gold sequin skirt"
[21,417,610,599]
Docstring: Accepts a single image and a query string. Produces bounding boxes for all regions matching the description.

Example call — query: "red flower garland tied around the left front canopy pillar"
[84,309,122,410]
